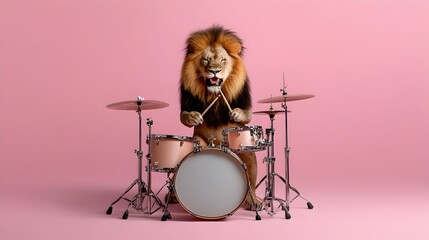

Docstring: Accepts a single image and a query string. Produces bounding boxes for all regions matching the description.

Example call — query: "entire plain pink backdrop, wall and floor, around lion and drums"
[0,0,429,239]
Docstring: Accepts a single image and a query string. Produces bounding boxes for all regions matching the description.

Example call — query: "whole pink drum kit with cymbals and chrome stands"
[106,85,314,221]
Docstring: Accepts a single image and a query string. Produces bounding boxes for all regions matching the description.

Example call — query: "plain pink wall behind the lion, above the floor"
[0,0,429,193]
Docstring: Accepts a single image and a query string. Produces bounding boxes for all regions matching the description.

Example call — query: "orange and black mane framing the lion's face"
[180,26,251,128]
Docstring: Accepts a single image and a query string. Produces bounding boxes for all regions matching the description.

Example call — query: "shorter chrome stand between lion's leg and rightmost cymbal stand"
[256,104,291,219]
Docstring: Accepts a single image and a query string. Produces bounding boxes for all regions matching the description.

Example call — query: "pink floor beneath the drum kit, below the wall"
[0,179,429,240]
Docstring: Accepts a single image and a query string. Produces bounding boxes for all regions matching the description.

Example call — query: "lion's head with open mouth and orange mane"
[181,26,248,102]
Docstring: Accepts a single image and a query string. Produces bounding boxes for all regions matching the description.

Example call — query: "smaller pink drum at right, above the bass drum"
[222,126,265,153]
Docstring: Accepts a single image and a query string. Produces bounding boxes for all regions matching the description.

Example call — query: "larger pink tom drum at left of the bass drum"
[150,134,197,172]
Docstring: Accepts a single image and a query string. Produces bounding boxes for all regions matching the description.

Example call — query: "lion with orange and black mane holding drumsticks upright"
[180,26,262,210]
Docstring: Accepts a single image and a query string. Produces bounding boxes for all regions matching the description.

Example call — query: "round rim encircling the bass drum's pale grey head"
[173,146,249,220]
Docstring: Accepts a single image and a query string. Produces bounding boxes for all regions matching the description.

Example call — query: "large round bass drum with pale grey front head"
[174,147,248,219]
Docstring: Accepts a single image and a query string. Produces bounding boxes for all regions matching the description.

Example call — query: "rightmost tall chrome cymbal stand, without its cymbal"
[280,83,313,214]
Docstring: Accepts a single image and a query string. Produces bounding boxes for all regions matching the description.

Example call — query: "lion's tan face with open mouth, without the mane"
[199,45,234,93]
